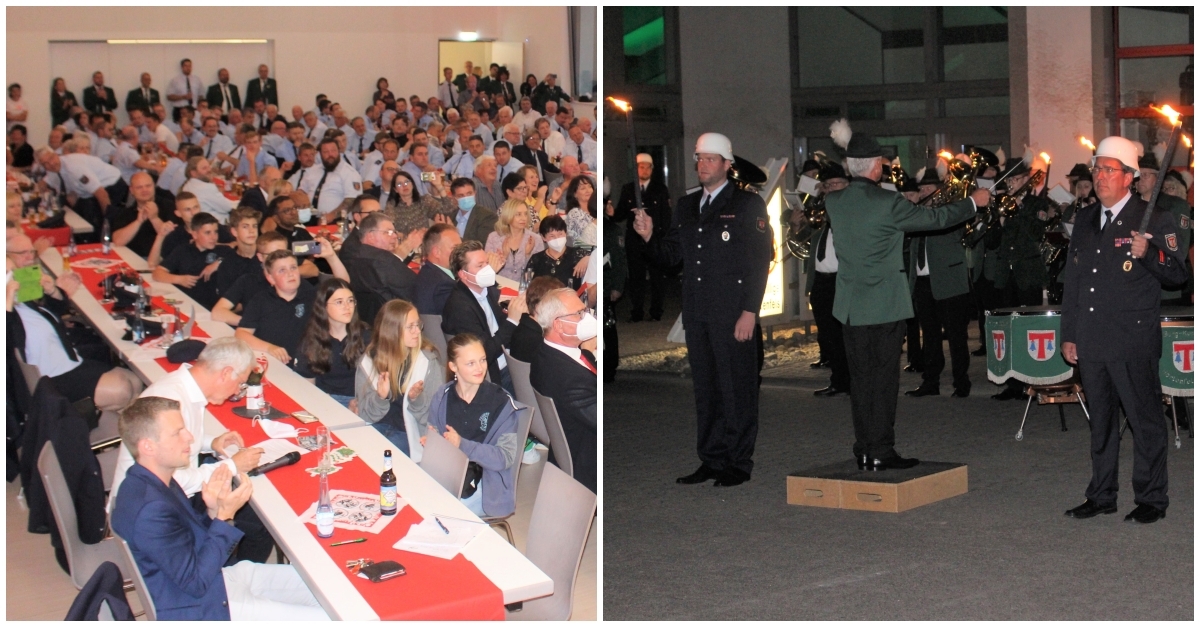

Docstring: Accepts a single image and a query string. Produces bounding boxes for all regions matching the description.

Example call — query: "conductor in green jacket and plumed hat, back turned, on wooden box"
[826,119,991,471]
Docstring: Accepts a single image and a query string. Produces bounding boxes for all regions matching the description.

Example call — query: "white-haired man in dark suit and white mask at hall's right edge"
[529,288,596,491]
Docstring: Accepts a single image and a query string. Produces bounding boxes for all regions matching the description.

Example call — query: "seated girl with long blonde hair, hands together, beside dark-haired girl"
[354,299,448,454]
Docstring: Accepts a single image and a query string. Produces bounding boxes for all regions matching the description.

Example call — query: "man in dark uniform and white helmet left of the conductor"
[634,133,773,485]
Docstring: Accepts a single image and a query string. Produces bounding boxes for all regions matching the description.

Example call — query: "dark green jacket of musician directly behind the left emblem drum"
[989,193,1050,289]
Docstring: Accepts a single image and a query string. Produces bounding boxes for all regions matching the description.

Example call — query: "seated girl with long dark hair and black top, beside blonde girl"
[294,276,367,407]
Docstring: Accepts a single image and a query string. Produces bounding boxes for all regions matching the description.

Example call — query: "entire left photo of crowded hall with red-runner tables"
[6,7,602,620]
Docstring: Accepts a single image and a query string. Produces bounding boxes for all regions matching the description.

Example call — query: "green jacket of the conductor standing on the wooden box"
[826,177,976,327]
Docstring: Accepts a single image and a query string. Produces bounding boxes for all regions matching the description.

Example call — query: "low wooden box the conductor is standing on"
[787,460,967,513]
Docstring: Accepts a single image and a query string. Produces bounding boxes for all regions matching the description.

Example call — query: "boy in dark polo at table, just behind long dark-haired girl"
[236,250,317,364]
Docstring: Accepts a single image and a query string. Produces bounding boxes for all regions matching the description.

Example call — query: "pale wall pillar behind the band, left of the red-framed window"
[1013,6,1102,187]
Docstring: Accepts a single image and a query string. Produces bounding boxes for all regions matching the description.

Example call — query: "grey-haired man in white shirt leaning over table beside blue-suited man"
[108,338,263,510]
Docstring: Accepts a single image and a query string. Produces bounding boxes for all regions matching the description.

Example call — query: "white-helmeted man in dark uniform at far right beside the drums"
[1062,137,1190,524]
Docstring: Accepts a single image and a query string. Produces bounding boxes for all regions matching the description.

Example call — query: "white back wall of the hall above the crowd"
[6,7,572,145]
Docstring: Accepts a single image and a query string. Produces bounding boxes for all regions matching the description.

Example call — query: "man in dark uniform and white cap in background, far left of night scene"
[612,153,671,322]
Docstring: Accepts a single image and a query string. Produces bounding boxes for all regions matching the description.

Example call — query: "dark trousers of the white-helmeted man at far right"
[1079,359,1168,509]
